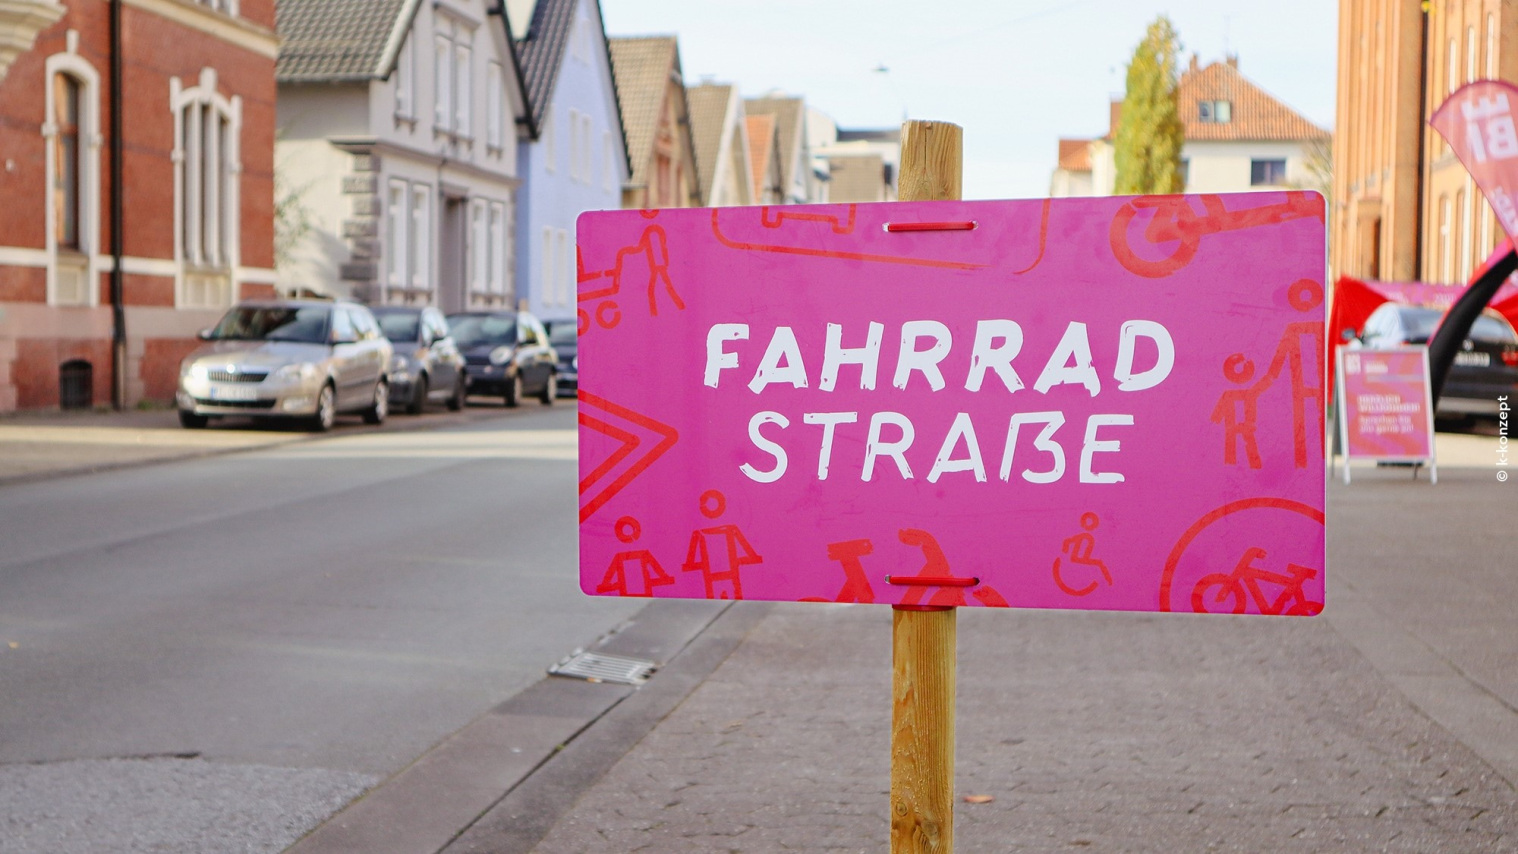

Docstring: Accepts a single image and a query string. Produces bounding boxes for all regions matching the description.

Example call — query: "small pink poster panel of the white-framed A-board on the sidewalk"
[1339,347,1433,461]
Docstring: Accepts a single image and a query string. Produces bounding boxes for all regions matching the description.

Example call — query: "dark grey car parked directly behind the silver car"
[369,305,465,416]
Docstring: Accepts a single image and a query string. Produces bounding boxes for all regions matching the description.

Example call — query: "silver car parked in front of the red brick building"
[176,300,392,431]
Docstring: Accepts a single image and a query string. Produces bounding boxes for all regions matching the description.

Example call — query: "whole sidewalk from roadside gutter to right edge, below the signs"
[445,437,1518,854]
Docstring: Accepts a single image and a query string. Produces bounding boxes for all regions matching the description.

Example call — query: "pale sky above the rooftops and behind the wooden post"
[601,0,1339,199]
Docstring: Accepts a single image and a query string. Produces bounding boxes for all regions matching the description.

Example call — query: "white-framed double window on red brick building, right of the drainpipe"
[168,68,243,308]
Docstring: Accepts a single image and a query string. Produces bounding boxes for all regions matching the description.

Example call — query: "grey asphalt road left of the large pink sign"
[0,405,639,852]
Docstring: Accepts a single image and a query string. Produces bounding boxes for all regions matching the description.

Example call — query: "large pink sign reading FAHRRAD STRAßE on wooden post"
[578,193,1325,614]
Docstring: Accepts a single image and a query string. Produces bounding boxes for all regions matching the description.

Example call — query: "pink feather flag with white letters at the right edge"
[1428,80,1518,240]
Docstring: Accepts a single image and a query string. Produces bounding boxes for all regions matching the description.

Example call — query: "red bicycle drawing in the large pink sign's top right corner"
[1108,190,1324,279]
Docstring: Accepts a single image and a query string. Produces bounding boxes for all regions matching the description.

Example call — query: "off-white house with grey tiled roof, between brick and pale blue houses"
[275,0,527,311]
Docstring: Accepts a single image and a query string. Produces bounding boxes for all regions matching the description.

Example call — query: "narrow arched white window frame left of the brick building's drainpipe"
[41,40,103,305]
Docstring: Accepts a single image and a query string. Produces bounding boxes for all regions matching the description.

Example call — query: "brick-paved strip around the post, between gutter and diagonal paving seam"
[536,605,1518,854]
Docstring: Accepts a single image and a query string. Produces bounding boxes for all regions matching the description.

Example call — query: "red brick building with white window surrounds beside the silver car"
[0,0,278,413]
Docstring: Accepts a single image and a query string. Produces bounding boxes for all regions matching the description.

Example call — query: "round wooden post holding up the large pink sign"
[891,121,962,854]
